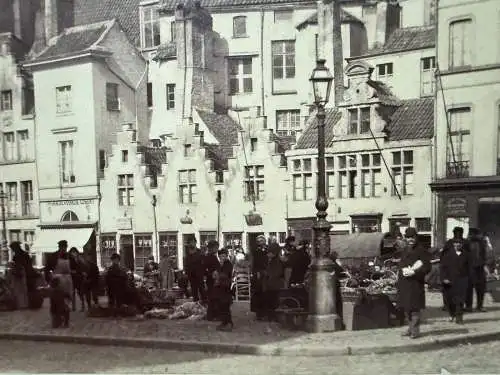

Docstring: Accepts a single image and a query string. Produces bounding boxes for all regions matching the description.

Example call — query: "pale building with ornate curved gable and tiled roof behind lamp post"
[286,62,434,247]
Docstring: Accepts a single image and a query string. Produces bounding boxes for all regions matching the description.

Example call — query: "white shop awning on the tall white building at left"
[32,228,94,253]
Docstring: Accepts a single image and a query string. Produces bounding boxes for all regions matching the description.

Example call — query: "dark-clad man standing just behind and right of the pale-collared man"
[465,228,487,312]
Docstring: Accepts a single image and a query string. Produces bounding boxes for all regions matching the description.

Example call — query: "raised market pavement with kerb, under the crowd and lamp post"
[0,293,500,348]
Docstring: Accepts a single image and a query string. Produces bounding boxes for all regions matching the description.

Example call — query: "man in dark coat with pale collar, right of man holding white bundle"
[439,232,471,324]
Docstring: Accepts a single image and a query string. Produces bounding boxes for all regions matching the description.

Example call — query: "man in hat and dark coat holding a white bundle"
[398,227,431,339]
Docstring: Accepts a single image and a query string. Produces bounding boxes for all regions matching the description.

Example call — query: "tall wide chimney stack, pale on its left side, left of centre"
[175,1,214,131]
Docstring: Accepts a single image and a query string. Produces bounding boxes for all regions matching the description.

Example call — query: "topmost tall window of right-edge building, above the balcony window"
[449,19,472,68]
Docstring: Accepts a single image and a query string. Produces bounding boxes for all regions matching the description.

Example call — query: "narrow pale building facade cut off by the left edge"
[0,33,38,264]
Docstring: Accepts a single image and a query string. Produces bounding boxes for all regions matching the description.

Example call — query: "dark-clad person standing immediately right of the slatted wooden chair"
[250,235,268,320]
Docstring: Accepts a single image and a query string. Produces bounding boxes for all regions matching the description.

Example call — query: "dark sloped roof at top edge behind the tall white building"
[74,0,141,46]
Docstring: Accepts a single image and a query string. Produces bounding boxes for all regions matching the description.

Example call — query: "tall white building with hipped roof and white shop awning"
[24,20,149,262]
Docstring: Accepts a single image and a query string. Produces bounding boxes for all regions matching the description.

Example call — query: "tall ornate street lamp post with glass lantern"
[306,59,342,332]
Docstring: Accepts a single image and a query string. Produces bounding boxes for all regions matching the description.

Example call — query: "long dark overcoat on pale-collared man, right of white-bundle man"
[440,249,472,304]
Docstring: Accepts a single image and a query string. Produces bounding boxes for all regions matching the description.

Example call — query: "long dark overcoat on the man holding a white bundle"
[398,245,431,311]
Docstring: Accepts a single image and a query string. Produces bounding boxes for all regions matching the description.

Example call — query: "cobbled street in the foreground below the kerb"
[0,341,500,375]
